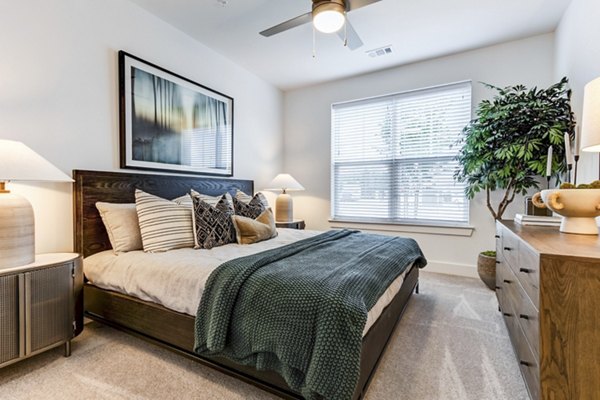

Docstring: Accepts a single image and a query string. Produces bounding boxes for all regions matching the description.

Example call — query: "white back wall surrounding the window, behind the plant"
[284,34,554,275]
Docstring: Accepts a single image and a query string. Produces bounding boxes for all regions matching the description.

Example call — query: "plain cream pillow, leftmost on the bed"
[96,201,142,254]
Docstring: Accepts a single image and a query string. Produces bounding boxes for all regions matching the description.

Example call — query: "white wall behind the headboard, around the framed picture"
[0,0,283,252]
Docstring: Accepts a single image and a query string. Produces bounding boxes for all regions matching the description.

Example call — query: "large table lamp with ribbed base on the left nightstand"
[0,140,73,269]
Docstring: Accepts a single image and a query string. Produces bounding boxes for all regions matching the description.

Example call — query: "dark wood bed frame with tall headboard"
[73,170,419,399]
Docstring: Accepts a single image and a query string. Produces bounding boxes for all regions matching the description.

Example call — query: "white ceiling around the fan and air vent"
[131,0,570,90]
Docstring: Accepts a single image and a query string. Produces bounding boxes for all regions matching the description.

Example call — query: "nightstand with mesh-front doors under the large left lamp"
[0,253,83,367]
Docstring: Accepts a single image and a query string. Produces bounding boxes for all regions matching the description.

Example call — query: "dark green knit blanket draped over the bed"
[194,230,427,399]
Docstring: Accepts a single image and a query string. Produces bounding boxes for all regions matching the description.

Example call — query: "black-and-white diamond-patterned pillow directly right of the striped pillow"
[192,195,236,249]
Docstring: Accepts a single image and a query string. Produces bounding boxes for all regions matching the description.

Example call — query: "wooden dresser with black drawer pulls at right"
[496,221,600,400]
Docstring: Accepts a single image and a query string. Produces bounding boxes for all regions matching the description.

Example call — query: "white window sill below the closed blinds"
[329,219,475,237]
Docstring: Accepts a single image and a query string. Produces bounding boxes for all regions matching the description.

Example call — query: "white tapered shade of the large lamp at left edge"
[0,140,73,182]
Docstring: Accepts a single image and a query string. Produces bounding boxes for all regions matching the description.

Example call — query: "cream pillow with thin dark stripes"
[135,189,194,253]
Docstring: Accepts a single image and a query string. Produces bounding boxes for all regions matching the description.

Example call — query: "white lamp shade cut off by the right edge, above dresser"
[581,78,600,153]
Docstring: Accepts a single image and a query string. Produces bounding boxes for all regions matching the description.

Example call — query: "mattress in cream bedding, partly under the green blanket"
[83,229,410,336]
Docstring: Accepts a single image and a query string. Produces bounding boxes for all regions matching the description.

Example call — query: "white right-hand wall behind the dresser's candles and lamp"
[555,0,600,182]
